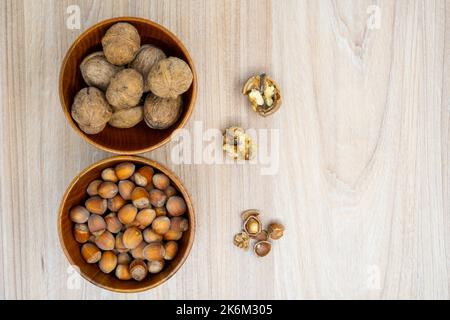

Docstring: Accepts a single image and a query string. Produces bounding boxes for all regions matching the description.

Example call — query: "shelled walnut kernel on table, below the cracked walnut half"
[223,127,256,160]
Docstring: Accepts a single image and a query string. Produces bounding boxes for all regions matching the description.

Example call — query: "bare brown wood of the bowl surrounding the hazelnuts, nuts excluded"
[58,156,195,292]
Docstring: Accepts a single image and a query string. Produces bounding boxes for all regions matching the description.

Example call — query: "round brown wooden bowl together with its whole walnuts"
[59,17,197,155]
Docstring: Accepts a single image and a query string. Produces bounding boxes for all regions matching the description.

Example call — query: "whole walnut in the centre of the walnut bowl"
[106,69,144,111]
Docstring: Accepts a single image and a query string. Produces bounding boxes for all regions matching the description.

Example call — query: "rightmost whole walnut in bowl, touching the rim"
[147,57,193,98]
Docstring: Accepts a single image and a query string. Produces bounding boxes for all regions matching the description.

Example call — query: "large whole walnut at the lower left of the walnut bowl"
[71,87,112,134]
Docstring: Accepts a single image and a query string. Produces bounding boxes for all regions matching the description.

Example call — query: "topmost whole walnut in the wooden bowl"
[102,22,141,66]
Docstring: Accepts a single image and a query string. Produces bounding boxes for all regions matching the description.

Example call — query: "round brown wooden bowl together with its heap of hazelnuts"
[58,156,195,292]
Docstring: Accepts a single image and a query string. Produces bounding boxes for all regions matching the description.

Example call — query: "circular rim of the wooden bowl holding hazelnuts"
[57,155,196,293]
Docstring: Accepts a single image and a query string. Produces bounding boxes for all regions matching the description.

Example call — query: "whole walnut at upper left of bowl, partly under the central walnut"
[80,52,122,91]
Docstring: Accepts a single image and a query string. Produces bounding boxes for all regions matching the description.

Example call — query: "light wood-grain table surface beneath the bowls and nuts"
[0,0,450,299]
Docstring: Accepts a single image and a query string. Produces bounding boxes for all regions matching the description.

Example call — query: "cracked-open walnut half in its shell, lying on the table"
[242,73,282,117]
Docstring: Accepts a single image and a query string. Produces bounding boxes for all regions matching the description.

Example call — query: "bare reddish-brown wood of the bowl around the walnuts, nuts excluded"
[59,17,197,154]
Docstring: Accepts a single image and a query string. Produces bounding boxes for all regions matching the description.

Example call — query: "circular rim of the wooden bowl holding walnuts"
[58,16,198,155]
